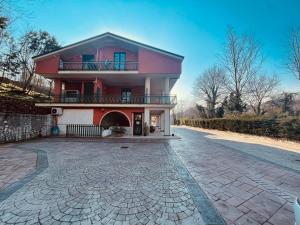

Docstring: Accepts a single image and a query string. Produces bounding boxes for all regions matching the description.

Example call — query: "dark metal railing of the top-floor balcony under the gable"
[59,60,139,71]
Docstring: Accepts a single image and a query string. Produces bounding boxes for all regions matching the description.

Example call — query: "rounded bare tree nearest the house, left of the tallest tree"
[194,66,226,118]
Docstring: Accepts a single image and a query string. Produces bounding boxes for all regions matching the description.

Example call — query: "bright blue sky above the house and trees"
[11,0,300,102]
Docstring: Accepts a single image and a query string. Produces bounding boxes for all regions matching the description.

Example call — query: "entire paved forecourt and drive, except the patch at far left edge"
[0,128,300,225]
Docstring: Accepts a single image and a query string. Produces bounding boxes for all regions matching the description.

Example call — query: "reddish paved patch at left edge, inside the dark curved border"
[0,144,36,190]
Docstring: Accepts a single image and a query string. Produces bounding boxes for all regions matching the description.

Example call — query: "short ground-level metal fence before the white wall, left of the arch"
[66,124,102,137]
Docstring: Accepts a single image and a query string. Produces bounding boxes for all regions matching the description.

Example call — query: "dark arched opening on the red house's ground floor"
[100,111,130,129]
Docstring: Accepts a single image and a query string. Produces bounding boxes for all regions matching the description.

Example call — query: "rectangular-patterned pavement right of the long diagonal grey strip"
[171,128,300,225]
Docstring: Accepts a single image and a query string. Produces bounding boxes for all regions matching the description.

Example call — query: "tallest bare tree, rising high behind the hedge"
[222,28,263,112]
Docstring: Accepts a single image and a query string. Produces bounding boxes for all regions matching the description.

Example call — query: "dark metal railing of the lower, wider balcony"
[49,95,177,105]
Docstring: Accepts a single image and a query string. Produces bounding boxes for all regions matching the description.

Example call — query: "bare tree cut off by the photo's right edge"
[287,28,300,80]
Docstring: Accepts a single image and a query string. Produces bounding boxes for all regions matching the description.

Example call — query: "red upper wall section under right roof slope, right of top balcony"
[139,48,181,74]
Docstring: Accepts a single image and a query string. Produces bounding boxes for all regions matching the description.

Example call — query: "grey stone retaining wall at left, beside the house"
[0,113,52,143]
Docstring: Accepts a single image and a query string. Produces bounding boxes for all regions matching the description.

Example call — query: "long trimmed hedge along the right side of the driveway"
[176,118,300,141]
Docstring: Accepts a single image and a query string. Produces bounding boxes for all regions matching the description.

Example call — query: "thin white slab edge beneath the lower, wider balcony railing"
[35,103,175,109]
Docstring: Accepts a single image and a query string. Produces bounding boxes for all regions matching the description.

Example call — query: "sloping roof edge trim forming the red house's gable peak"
[34,33,183,61]
